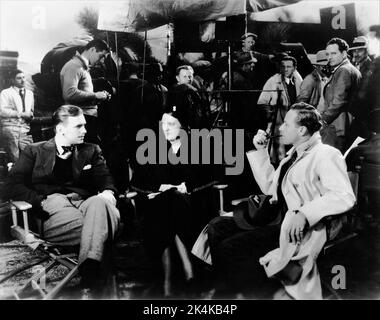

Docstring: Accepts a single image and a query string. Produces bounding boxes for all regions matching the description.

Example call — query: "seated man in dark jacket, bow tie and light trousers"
[4,105,120,298]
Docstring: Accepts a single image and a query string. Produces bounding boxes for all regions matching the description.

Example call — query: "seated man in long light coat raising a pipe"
[208,102,355,299]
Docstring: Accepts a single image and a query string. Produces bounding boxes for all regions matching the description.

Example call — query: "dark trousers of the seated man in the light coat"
[208,217,280,298]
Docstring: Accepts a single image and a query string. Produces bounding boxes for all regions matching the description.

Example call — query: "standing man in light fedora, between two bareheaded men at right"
[297,50,328,112]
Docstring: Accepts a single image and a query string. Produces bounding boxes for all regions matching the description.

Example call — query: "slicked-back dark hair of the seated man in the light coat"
[290,102,323,135]
